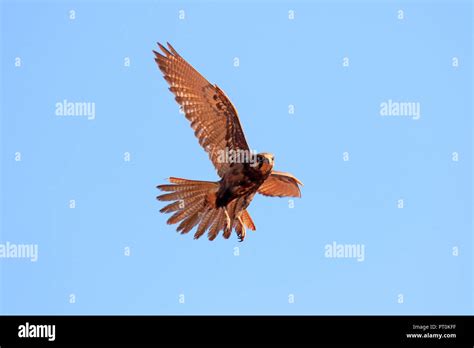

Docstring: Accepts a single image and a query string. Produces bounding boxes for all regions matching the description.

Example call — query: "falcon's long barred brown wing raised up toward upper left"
[153,43,249,177]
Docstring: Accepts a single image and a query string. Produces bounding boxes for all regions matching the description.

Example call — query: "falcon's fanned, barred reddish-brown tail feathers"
[156,178,255,240]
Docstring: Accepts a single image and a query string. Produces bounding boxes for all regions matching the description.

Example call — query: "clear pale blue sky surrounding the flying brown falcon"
[0,0,474,314]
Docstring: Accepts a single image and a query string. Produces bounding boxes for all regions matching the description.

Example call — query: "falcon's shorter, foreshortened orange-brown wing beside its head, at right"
[258,170,303,197]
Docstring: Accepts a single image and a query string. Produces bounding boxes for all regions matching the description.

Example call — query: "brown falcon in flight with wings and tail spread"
[153,43,302,241]
